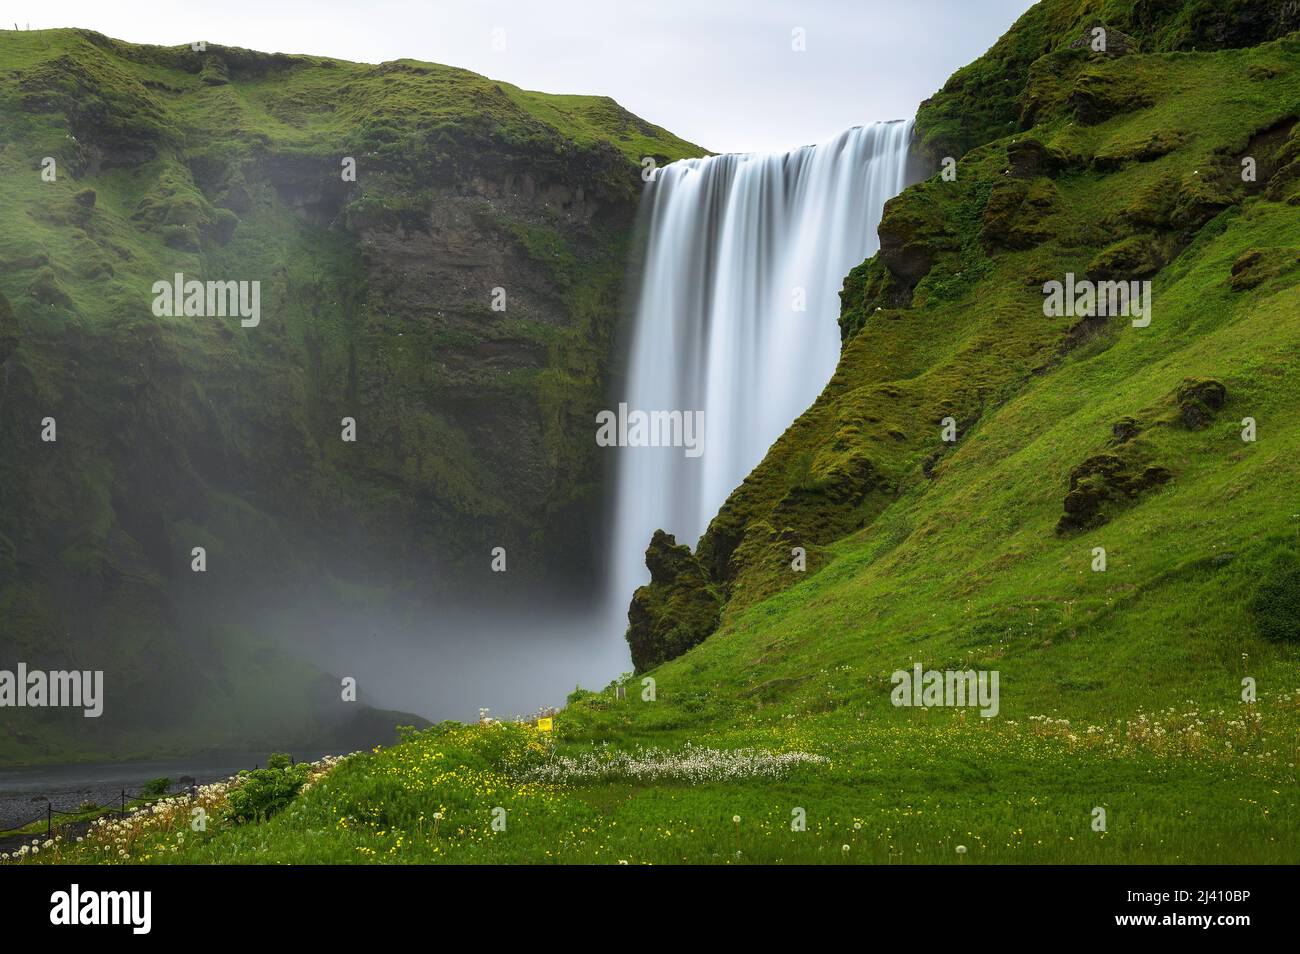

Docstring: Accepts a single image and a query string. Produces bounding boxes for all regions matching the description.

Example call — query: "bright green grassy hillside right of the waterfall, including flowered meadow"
[10,3,1300,863]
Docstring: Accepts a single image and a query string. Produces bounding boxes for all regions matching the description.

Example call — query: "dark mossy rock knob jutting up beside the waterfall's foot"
[627,530,723,672]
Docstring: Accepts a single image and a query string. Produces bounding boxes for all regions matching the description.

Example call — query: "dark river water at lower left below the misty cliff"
[0,753,324,831]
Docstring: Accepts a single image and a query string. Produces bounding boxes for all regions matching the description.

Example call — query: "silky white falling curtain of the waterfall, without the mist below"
[610,121,911,621]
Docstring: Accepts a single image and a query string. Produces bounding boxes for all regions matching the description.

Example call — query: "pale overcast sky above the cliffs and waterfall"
[20,0,1032,152]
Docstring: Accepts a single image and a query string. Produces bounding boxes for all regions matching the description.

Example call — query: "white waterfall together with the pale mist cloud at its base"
[287,122,915,720]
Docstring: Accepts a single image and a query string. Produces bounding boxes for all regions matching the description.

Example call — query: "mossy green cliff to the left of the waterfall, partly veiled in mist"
[0,30,699,758]
